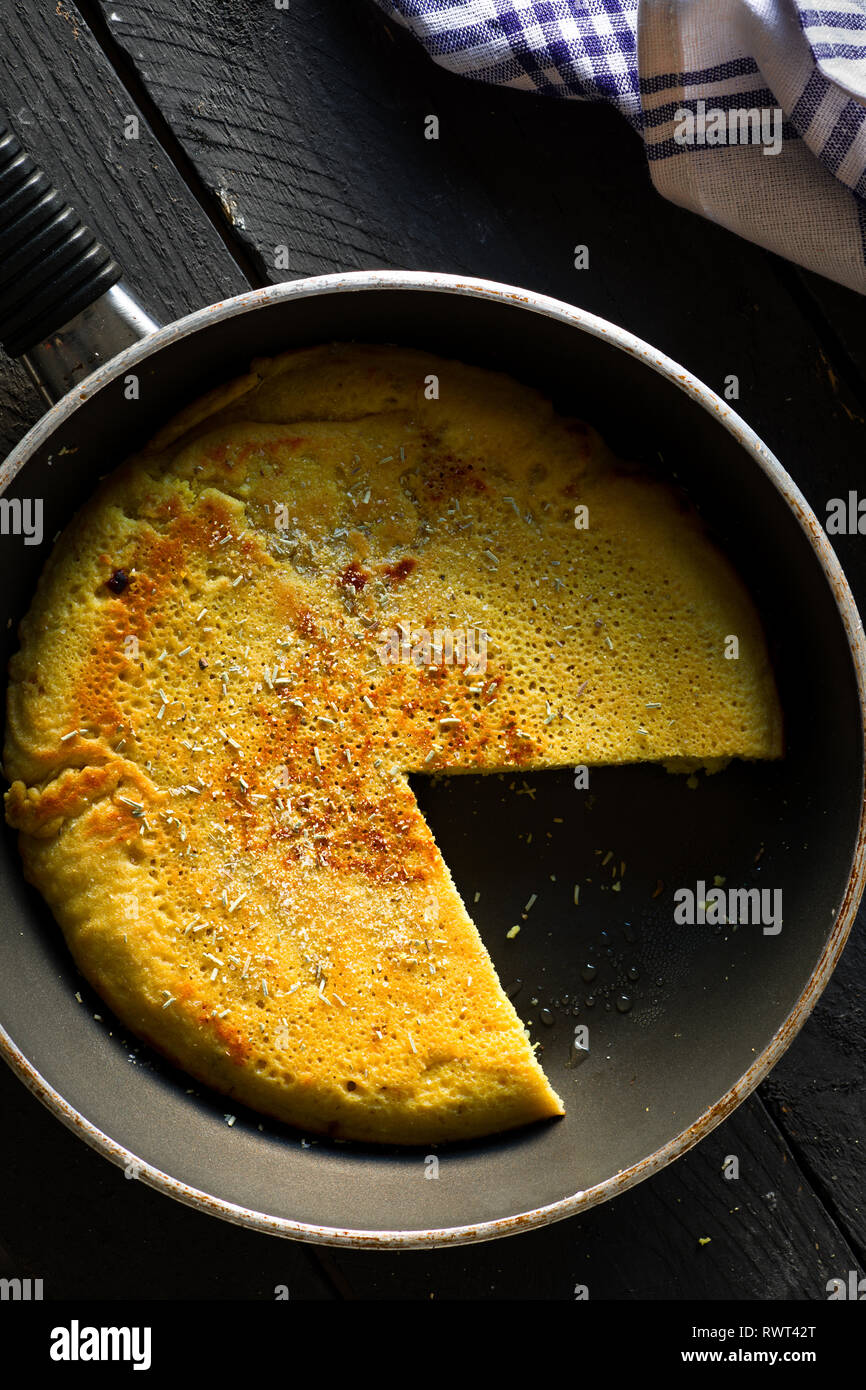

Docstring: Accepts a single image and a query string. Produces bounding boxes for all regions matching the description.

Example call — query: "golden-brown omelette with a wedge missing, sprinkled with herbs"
[4,345,783,1144]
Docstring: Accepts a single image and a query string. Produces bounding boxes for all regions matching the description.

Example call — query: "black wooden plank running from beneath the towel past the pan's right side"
[101,0,866,1273]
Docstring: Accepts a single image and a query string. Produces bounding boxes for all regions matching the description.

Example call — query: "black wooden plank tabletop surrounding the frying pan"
[0,0,866,1300]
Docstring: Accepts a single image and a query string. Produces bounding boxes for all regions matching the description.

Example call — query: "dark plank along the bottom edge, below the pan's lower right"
[329,1098,858,1302]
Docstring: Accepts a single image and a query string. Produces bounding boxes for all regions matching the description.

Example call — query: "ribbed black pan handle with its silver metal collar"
[0,117,158,403]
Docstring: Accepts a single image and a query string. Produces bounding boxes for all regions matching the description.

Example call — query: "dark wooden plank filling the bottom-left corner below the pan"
[0,1066,336,1301]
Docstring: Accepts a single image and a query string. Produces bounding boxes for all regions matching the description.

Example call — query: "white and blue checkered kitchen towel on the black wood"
[377,0,866,293]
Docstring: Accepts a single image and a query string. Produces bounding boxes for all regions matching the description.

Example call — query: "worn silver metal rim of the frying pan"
[0,270,866,1250]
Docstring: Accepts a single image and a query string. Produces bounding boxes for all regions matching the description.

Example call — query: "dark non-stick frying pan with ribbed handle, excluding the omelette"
[0,116,865,1248]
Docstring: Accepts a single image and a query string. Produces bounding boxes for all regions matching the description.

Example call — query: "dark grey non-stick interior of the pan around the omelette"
[0,288,863,1238]
